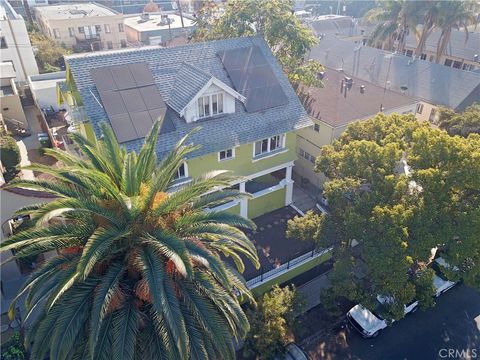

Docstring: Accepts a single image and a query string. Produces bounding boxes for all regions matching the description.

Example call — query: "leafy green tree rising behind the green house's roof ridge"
[194,0,322,88]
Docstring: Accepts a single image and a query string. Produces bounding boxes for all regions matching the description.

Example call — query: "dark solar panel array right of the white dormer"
[218,46,288,112]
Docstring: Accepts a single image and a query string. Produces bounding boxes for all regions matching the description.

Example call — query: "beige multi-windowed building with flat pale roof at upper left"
[35,3,127,51]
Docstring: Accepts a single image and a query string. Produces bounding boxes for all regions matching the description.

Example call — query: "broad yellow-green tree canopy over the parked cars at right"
[288,114,480,318]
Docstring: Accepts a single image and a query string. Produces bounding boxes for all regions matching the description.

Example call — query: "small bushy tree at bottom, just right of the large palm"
[244,285,303,360]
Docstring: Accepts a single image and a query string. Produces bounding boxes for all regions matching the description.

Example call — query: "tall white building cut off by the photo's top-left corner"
[0,0,38,82]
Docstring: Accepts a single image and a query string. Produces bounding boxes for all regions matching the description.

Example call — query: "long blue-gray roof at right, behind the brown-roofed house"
[310,35,480,110]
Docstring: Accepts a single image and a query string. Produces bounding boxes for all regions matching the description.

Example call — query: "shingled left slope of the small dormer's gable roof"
[168,62,212,112]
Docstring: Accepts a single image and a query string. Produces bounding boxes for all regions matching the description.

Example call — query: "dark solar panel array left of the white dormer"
[90,63,175,143]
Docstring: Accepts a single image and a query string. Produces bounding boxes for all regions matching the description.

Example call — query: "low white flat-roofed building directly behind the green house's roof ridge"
[124,13,195,45]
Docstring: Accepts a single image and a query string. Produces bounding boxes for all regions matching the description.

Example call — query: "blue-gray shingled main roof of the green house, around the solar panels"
[66,37,312,157]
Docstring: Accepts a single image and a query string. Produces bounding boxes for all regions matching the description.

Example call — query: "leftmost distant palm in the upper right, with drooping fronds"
[365,0,423,53]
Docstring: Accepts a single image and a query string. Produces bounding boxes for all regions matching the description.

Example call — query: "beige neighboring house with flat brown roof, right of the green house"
[294,68,419,188]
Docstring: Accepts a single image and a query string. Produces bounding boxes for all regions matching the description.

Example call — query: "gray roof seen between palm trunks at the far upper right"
[407,30,480,61]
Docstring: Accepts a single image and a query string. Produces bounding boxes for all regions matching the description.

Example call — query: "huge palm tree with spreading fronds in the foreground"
[1,123,259,360]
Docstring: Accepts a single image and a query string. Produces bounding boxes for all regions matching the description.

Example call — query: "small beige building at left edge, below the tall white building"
[0,62,28,129]
